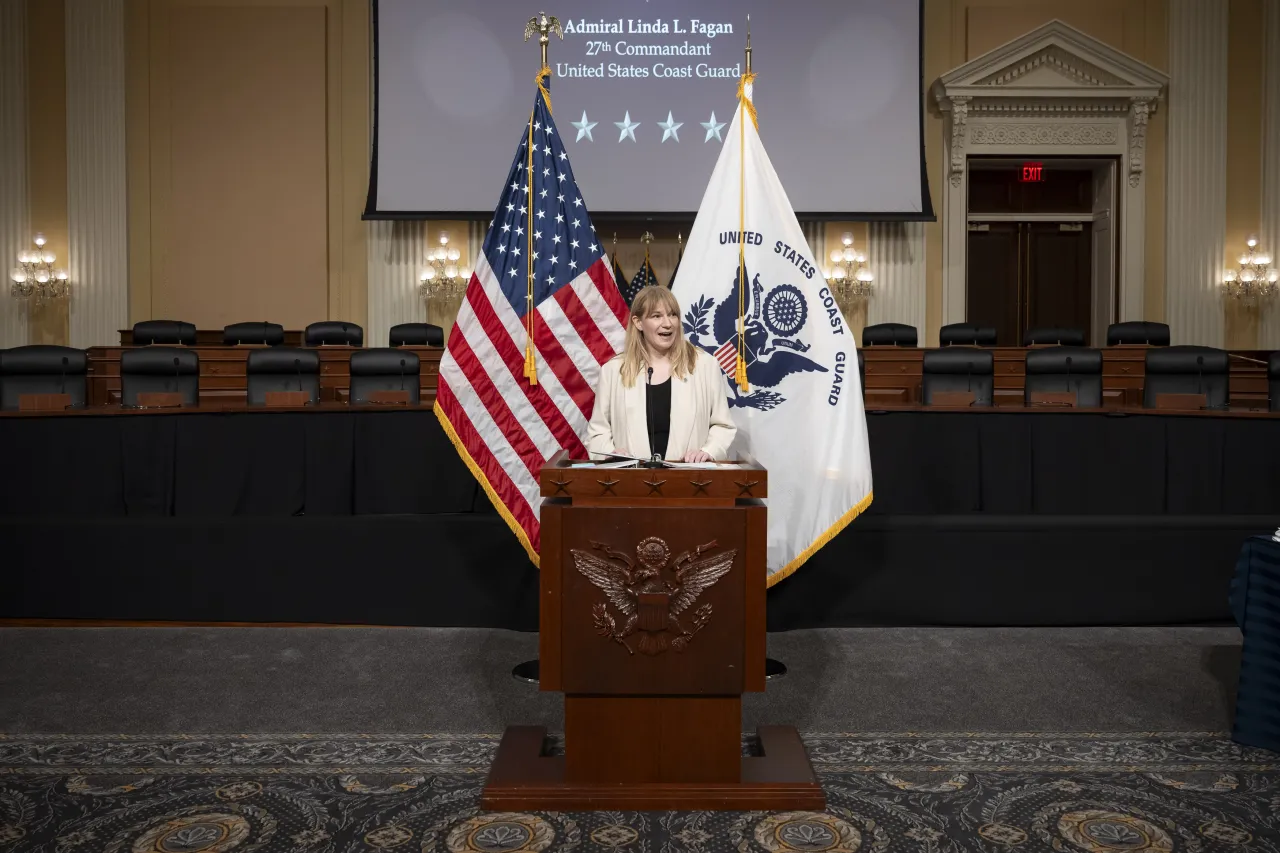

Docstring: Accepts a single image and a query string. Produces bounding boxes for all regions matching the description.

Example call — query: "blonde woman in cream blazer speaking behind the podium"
[586,286,737,462]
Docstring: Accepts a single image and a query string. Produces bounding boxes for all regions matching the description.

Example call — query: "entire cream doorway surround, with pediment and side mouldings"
[933,20,1169,324]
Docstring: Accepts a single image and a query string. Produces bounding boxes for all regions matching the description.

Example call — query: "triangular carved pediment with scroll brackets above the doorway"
[933,20,1169,186]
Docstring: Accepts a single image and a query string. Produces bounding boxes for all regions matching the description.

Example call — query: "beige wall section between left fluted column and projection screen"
[125,0,369,329]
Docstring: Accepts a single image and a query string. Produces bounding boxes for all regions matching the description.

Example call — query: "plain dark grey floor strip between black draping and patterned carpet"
[0,628,1240,734]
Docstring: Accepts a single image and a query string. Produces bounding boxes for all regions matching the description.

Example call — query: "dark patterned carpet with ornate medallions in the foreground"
[0,734,1280,853]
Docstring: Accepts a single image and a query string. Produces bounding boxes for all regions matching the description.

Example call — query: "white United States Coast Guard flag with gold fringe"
[672,74,872,587]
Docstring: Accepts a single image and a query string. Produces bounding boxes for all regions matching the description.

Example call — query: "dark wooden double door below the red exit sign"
[965,222,1093,346]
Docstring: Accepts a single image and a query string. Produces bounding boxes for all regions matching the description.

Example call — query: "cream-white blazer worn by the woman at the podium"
[586,350,737,460]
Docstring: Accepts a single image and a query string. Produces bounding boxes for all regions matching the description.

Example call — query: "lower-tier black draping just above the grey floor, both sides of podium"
[0,512,1276,625]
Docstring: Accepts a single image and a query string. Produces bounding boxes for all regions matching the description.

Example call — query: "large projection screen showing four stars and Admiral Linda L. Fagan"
[365,0,933,219]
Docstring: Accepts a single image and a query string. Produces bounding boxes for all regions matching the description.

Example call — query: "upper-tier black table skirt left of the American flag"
[0,411,492,517]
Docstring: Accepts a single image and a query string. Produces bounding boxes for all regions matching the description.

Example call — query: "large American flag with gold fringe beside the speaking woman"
[435,91,627,564]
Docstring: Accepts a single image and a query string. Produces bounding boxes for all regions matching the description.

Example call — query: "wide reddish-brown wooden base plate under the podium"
[480,726,827,811]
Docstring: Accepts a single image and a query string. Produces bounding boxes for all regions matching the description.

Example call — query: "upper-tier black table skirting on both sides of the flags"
[0,411,1280,517]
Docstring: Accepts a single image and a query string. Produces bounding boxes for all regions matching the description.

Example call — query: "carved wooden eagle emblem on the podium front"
[570,537,737,654]
